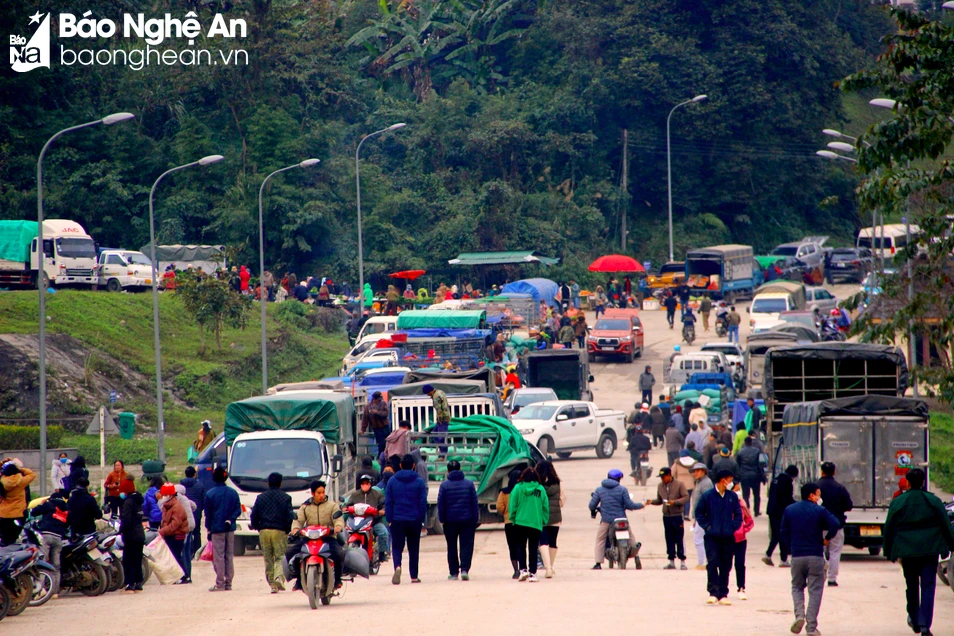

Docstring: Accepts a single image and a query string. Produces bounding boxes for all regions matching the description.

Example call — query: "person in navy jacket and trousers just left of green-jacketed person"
[437,460,480,581]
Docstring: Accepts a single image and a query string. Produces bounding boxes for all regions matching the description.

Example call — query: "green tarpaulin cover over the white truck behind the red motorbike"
[225,391,354,445]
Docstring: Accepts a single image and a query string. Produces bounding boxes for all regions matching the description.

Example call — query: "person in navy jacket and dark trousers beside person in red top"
[695,470,742,605]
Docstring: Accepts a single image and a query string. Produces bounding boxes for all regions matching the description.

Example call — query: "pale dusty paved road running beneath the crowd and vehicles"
[16,286,954,636]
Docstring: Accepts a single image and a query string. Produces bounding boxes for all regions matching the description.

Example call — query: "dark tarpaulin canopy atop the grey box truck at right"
[782,395,929,446]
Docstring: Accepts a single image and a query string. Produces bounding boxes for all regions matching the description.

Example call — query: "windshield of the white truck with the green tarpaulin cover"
[229,437,324,490]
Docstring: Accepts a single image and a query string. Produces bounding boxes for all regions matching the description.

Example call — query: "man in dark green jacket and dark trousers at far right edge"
[883,468,954,636]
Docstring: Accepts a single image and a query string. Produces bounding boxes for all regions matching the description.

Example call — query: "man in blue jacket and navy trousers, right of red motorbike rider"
[384,455,427,585]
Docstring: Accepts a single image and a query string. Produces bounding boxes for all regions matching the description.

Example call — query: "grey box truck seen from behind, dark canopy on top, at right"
[775,395,929,555]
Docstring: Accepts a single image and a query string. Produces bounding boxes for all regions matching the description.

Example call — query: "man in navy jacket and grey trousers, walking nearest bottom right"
[781,482,841,636]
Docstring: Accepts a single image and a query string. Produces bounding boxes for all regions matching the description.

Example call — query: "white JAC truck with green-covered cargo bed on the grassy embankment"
[0,219,99,288]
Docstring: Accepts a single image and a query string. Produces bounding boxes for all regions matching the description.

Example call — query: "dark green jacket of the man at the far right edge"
[876,489,954,561]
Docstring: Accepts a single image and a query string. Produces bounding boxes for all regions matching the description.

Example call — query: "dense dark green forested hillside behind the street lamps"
[0,0,890,282]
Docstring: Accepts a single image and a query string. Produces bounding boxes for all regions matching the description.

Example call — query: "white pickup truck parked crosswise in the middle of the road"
[511,400,626,459]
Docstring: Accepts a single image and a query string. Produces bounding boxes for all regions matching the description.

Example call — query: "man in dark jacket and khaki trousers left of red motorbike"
[249,473,292,594]
